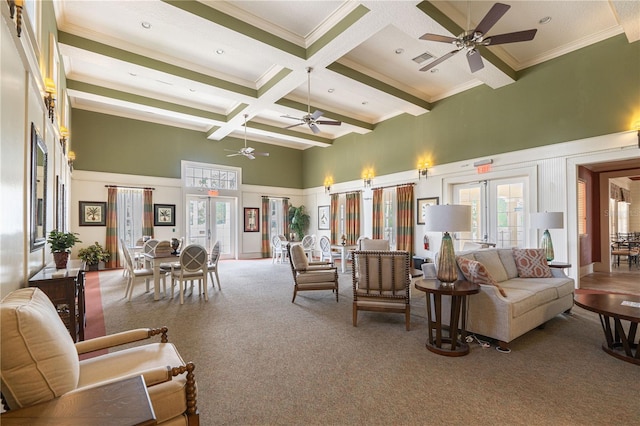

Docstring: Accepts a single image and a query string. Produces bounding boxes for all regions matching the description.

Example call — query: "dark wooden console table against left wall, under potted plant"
[29,260,86,342]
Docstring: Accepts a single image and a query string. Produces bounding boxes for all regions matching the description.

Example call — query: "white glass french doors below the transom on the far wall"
[186,195,237,258]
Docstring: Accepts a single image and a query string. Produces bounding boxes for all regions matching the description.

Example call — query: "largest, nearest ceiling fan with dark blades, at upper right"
[420,3,538,72]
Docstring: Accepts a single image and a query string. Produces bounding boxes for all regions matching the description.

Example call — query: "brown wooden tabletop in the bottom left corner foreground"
[0,376,157,426]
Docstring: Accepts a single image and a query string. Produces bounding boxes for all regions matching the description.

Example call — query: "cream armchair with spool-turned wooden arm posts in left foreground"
[0,287,199,425]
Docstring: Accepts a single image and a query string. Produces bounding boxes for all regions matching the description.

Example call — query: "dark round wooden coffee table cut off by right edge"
[575,294,640,365]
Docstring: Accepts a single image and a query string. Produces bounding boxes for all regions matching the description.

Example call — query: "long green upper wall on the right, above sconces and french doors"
[303,35,640,188]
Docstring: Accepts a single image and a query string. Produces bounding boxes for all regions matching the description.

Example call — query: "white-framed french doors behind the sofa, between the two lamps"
[453,177,528,248]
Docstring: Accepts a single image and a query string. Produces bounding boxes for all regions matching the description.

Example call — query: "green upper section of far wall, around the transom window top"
[73,109,302,188]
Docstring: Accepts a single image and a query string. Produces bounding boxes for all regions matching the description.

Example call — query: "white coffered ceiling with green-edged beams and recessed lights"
[54,0,640,149]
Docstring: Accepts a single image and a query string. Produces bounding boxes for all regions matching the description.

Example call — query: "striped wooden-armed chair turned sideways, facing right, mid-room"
[287,244,338,303]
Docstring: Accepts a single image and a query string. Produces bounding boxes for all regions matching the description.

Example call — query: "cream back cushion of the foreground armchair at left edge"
[0,287,80,409]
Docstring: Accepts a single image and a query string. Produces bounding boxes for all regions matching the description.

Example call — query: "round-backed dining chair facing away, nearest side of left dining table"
[171,244,209,305]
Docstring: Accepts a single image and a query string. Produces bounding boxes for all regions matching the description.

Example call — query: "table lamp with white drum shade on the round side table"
[424,204,471,285]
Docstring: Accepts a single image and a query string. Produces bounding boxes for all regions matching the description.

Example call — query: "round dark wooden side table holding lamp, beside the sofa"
[415,279,480,356]
